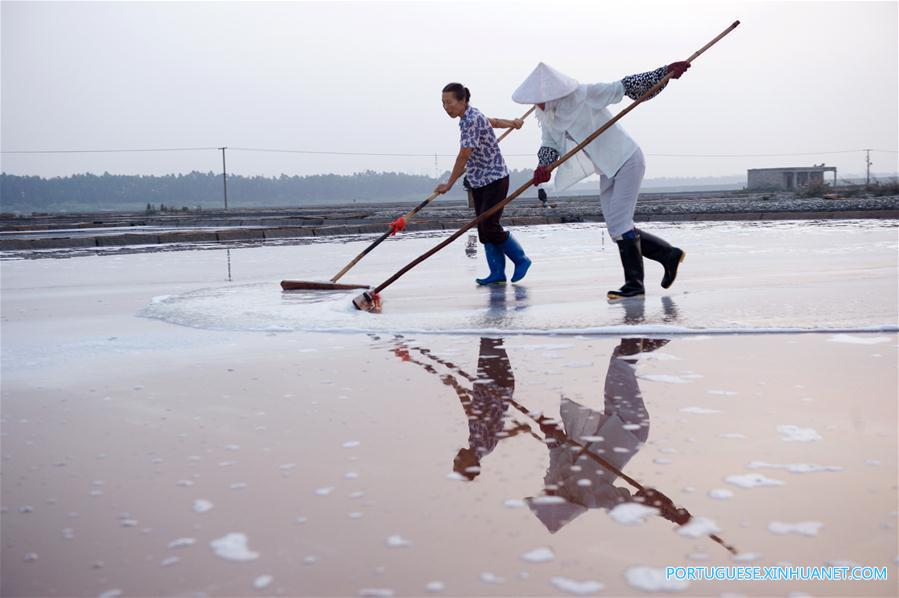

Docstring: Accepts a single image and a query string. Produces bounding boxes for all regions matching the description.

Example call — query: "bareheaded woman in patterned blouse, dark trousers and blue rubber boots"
[434,83,531,285]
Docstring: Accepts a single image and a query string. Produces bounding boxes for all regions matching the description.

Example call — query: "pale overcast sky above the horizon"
[0,0,899,178]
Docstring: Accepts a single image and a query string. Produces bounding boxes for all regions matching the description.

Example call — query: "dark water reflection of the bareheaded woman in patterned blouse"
[453,337,530,480]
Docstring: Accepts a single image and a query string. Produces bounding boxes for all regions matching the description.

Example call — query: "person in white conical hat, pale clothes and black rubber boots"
[512,62,690,300]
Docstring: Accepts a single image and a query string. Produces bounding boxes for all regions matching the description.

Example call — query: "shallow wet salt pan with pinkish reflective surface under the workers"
[0,221,899,596]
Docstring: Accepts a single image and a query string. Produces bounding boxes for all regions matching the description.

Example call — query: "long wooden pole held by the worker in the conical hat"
[353,21,740,309]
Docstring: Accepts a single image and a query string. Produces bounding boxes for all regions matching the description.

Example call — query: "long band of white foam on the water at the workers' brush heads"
[137,281,899,340]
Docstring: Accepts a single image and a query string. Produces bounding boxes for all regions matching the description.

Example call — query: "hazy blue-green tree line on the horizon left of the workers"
[0,170,533,213]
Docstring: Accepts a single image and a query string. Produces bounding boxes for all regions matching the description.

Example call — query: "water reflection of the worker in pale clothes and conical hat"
[526,338,669,533]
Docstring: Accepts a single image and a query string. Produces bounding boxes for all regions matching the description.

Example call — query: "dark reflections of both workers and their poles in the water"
[380,296,736,554]
